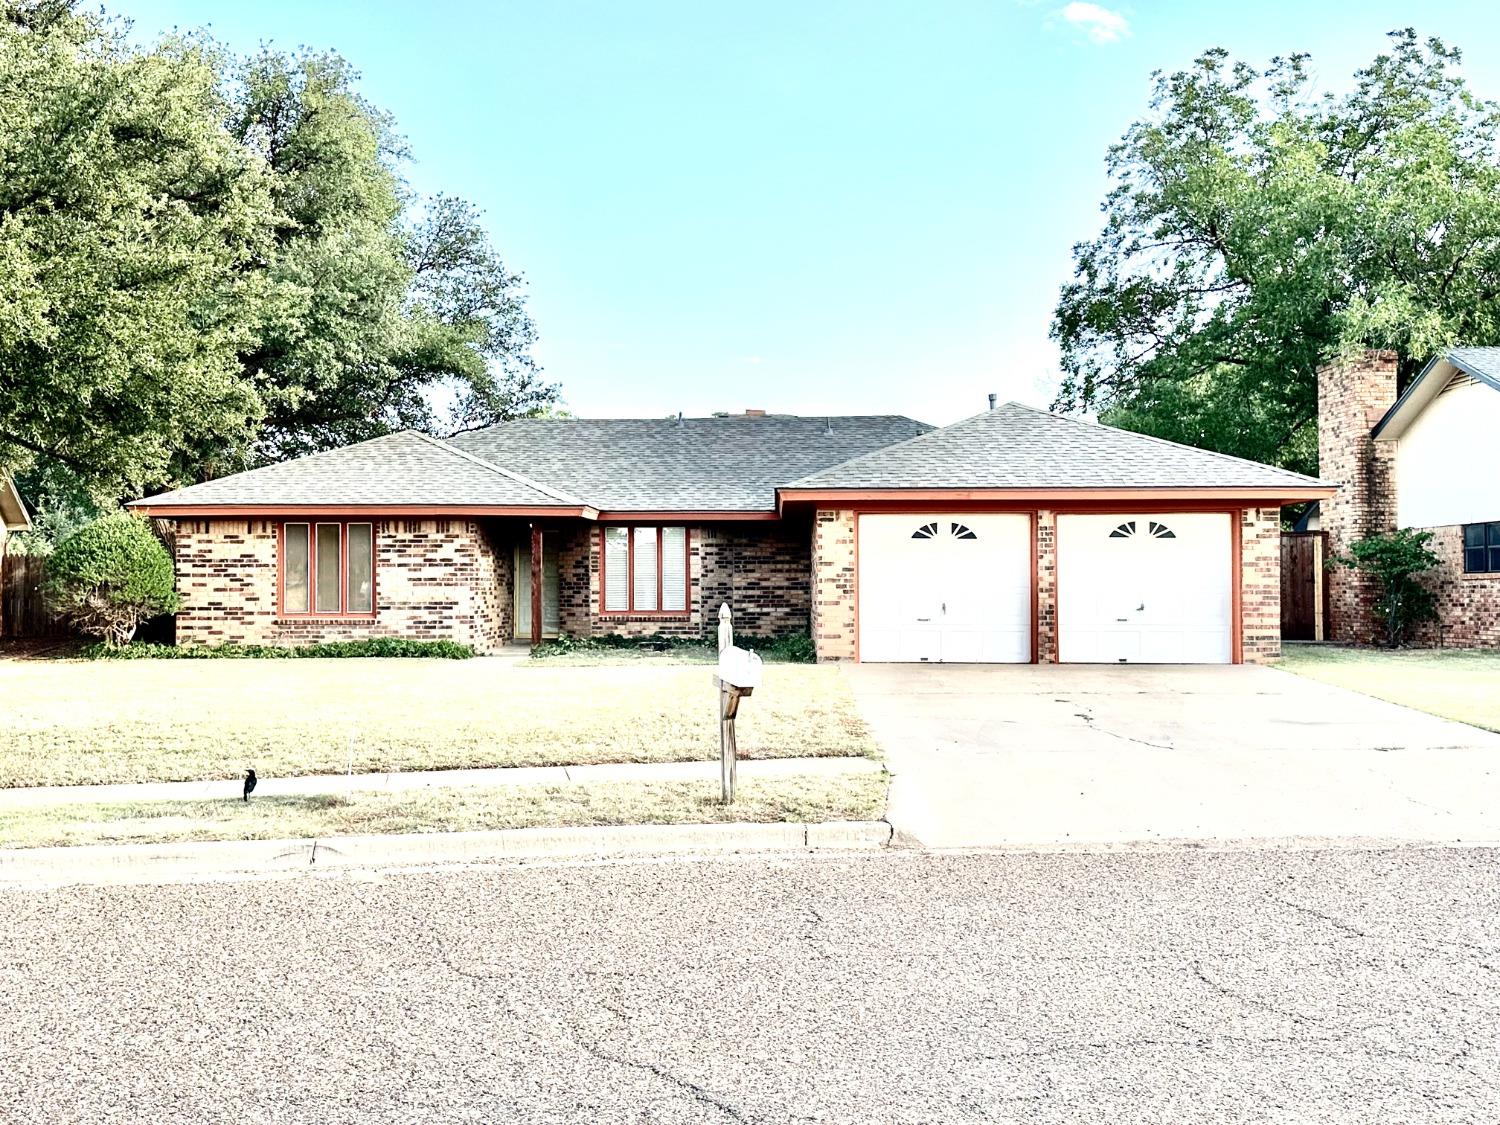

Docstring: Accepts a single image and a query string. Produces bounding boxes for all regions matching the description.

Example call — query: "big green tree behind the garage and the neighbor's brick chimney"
[1052,29,1500,471]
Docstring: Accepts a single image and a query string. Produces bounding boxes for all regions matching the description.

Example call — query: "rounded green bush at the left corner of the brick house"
[45,512,179,645]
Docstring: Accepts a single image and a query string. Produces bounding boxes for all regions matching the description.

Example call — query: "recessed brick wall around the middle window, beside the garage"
[558,521,812,638]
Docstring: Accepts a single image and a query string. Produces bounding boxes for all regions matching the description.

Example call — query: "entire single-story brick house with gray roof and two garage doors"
[134,404,1332,663]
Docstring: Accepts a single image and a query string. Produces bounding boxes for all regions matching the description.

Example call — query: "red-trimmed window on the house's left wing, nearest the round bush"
[281,521,375,617]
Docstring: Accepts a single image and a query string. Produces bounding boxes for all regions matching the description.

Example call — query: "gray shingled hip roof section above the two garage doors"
[789,402,1322,491]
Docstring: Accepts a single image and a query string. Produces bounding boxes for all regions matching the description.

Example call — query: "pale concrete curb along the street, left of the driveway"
[0,821,891,888]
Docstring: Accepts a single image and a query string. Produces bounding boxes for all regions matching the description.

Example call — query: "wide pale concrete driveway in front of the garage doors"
[846,665,1500,848]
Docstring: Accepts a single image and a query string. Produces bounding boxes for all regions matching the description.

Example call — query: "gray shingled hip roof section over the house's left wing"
[135,431,584,509]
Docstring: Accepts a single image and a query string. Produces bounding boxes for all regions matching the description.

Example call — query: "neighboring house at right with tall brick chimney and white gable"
[1317,348,1500,647]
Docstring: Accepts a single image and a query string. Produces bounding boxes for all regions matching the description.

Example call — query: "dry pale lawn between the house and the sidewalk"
[0,659,876,788]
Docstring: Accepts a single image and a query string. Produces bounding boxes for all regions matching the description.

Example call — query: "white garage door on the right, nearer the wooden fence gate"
[1058,513,1233,665]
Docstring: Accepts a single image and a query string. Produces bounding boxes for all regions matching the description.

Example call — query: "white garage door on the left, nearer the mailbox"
[860,513,1032,665]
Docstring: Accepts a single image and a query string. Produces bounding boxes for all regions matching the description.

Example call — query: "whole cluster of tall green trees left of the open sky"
[0,0,557,510]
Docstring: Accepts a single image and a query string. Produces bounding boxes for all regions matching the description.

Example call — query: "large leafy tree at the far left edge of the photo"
[0,0,273,495]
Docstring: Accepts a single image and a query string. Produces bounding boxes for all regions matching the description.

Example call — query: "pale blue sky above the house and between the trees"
[123,0,1500,423]
